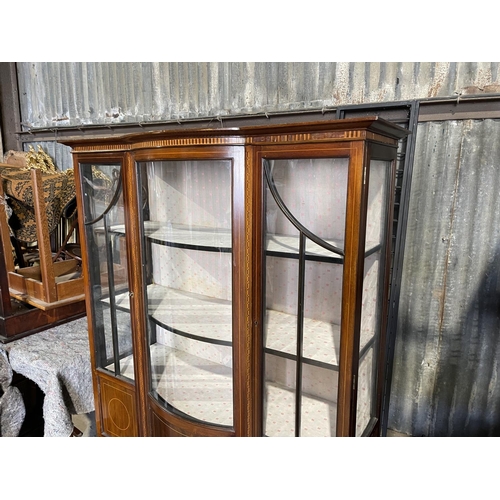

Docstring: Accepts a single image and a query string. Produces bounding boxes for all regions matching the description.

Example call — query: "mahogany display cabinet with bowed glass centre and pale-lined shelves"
[65,117,407,437]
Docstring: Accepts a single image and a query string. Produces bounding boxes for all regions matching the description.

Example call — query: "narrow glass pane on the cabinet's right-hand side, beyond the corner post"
[356,160,390,436]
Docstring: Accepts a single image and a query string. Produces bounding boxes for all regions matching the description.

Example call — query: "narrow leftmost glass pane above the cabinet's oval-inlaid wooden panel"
[80,163,134,380]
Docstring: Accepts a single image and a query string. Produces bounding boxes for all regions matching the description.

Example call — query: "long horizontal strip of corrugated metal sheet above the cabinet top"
[17,62,500,128]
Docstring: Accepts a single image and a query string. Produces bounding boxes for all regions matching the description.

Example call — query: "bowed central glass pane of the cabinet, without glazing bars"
[138,160,233,426]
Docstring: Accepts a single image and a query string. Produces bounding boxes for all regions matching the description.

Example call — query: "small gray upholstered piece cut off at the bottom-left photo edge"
[0,346,26,437]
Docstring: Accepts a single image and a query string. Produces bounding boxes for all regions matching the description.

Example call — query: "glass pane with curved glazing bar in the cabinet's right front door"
[263,158,349,437]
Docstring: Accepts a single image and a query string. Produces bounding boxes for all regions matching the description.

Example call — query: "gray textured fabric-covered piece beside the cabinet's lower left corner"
[6,318,94,437]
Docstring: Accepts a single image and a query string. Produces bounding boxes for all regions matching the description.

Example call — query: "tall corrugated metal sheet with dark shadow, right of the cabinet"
[389,120,500,436]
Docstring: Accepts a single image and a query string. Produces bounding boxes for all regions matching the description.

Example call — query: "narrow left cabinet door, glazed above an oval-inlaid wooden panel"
[77,158,137,436]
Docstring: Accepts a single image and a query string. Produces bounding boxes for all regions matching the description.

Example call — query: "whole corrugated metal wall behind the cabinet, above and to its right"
[7,62,500,436]
